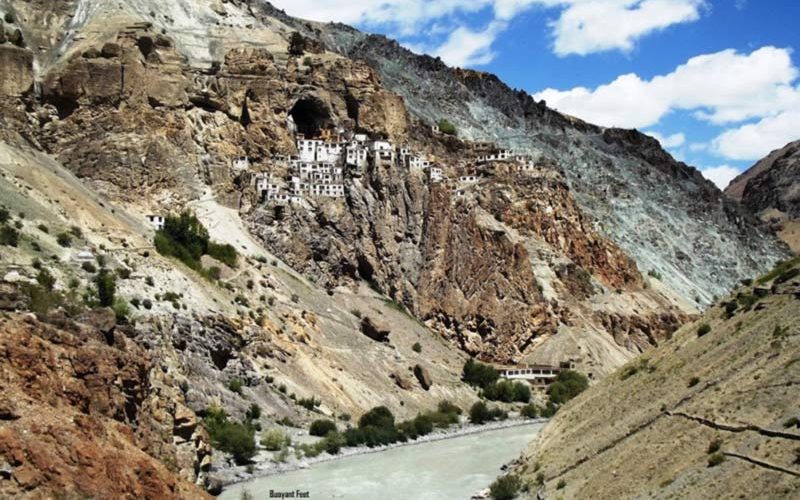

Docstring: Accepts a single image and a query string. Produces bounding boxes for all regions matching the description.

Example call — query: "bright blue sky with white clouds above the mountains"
[272,0,800,188]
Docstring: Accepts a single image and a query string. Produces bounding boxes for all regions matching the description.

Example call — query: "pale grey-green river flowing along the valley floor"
[219,424,542,500]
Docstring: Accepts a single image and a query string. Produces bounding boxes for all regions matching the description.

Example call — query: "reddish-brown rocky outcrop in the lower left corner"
[0,310,211,498]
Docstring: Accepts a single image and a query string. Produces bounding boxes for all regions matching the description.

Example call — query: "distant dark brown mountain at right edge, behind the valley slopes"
[725,141,800,252]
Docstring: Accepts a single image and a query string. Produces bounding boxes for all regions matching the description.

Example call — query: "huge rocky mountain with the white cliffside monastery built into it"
[0,0,788,496]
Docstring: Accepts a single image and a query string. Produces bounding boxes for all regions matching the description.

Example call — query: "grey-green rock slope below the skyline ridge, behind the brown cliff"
[321,32,786,305]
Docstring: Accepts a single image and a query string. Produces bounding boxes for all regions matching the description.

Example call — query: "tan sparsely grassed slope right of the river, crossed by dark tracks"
[518,264,800,499]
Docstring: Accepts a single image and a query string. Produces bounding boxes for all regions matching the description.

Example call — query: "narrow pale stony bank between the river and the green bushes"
[212,418,547,488]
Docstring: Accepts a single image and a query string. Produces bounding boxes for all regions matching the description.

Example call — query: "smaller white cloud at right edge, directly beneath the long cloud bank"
[711,107,800,160]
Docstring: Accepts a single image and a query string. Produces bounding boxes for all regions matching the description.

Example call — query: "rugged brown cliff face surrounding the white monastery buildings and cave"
[0,2,685,372]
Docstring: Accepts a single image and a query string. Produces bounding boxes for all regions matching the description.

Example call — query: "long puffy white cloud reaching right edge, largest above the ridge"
[534,47,800,128]
